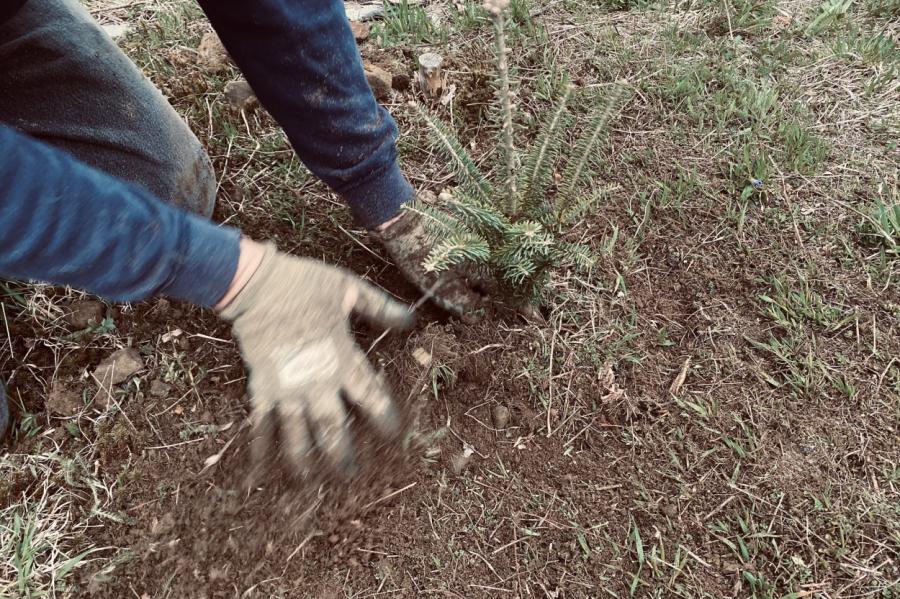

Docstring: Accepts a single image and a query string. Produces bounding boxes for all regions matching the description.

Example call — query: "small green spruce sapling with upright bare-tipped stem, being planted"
[407,0,623,303]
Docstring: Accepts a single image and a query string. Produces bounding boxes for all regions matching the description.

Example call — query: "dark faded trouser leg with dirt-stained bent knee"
[0,0,216,217]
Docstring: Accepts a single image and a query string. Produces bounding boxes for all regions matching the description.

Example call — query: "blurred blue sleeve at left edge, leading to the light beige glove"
[0,125,239,306]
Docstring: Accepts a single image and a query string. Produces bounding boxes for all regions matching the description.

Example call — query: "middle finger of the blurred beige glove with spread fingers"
[305,386,356,475]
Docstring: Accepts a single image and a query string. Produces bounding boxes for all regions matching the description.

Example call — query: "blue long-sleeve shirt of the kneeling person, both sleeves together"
[0,0,413,305]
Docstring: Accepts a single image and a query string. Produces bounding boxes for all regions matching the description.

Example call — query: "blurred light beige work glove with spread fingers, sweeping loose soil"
[220,244,413,473]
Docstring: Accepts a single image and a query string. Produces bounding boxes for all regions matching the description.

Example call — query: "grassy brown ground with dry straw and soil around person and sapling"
[0,0,900,598]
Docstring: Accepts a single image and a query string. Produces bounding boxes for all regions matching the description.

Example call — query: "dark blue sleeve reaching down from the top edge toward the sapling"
[200,0,414,228]
